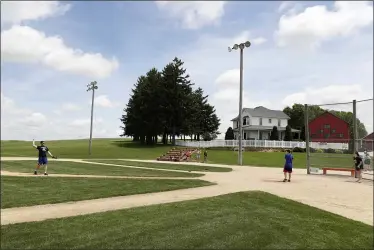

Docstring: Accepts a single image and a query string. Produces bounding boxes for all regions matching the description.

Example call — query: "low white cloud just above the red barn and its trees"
[282,84,374,133]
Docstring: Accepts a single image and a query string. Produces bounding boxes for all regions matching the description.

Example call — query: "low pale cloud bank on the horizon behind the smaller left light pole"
[1,92,121,140]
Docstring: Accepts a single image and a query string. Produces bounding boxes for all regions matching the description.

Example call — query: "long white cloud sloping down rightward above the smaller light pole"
[1,25,118,78]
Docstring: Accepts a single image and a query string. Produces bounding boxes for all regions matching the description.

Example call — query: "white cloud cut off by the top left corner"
[1,1,71,23]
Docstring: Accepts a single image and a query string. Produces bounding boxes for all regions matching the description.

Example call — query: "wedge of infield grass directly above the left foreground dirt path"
[1,176,212,209]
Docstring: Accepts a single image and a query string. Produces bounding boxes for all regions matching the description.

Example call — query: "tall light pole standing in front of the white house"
[229,41,251,165]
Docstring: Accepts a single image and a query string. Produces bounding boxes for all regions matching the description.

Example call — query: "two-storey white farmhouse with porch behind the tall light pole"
[231,106,300,140]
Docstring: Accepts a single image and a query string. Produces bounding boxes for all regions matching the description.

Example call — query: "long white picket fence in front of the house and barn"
[176,140,348,150]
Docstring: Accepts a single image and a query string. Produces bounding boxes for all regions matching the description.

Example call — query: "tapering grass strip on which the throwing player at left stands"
[1,161,203,177]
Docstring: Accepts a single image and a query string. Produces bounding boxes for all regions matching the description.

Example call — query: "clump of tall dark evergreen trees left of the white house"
[121,58,220,145]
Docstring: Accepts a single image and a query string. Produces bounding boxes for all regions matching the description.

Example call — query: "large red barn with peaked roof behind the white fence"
[309,111,350,143]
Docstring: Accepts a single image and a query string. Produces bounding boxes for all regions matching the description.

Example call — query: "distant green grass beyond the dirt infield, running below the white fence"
[1,139,353,168]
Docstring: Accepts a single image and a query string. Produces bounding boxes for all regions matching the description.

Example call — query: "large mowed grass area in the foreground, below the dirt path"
[1,192,373,249]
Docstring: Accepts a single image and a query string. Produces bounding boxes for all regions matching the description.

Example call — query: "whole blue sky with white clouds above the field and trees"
[1,1,373,140]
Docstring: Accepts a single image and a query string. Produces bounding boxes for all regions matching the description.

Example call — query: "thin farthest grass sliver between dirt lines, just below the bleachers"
[85,160,232,172]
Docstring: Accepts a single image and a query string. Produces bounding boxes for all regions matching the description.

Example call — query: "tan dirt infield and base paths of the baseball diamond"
[1,157,373,225]
